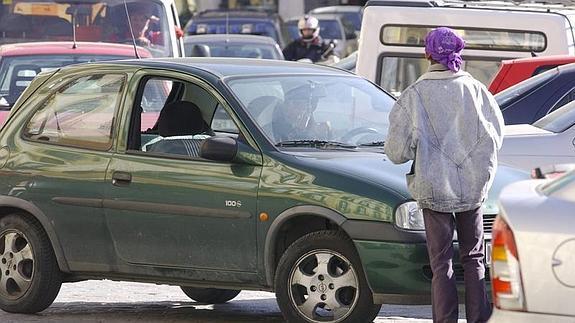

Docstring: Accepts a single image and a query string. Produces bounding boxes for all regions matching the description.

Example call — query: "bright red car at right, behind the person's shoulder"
[489,55,575,94]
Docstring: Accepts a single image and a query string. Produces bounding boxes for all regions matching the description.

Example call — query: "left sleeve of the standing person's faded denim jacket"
[384,100,415,164]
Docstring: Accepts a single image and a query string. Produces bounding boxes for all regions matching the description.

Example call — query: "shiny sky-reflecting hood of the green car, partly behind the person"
[280,151,530,214]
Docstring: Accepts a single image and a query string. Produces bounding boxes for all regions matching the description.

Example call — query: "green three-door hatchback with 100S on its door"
[0,58,525,322]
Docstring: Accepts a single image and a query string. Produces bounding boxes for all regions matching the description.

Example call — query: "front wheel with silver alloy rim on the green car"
[275,231,381,323]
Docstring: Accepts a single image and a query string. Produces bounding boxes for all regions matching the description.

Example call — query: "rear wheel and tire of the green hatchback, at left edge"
[0,214,62,314]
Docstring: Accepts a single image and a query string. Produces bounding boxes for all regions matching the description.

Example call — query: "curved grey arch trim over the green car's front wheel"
[264,205,347,286]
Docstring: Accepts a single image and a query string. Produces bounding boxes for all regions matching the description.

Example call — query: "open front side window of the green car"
[128,77,239,158]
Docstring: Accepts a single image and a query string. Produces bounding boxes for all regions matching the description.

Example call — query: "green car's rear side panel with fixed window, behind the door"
[11,68,126,272]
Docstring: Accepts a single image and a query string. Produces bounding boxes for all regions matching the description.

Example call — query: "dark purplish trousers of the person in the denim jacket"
[423,208,491,323]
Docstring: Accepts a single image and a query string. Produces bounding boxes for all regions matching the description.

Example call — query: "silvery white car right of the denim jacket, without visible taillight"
[499,101,575,171]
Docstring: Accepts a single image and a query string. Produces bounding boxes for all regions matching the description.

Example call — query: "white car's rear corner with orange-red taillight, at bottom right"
[489,171,575,323]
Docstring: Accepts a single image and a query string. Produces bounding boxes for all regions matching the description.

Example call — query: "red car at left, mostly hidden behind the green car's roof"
[0,42,152,124]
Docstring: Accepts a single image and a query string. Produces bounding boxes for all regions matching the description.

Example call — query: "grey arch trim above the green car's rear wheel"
[0,196,70,272]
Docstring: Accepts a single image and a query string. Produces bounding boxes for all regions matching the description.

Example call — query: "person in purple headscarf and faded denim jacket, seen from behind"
[385,27,504,323]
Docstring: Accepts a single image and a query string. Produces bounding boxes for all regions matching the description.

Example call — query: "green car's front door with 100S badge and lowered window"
[104,71,261,280]
